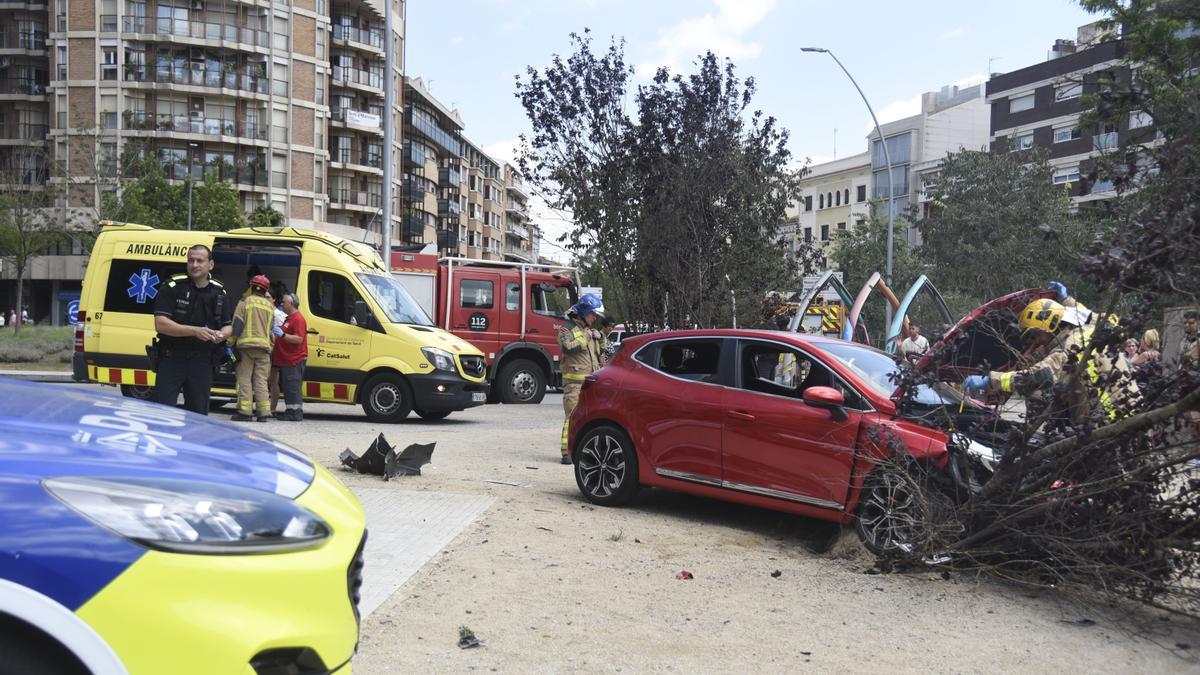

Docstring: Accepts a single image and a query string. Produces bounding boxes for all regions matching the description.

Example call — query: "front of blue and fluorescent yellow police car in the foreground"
[0,378,366,674]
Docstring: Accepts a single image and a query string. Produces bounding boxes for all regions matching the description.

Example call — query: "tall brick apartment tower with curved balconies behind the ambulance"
[0,0,408,322]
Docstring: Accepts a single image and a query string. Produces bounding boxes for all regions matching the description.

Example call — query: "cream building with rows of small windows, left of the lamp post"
[780,153,871,269]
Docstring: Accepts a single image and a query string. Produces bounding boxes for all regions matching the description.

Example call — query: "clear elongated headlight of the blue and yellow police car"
[43,478,330,554]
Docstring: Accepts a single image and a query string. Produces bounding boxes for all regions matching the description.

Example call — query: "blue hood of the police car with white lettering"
[0,378,313,498]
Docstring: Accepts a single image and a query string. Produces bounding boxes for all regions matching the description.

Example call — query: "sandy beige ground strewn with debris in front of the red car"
[231,395,1200,674]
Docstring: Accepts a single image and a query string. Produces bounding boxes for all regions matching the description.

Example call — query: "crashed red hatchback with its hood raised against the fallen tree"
[569,291,1038,552]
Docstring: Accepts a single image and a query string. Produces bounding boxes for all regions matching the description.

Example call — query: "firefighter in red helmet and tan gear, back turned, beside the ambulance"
[230,274,280,422]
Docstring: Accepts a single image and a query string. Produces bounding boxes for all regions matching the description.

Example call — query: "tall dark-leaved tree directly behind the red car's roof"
[517,34,798,325]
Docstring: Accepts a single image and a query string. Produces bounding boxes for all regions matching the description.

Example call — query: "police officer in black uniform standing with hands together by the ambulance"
[154,244,233,414]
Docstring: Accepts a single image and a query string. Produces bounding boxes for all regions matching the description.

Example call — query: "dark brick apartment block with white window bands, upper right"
[988,24,1156,205]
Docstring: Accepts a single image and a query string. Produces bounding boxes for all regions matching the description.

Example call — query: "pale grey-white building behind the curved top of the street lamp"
[868,83,990,245]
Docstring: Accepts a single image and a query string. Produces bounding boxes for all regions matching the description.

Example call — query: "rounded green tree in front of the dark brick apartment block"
[920,150,1085,305]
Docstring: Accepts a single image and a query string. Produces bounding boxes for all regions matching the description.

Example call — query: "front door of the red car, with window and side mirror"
[722,340,863,509]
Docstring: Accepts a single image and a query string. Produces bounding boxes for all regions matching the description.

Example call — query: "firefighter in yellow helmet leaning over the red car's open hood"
[962,298,1138,424]
